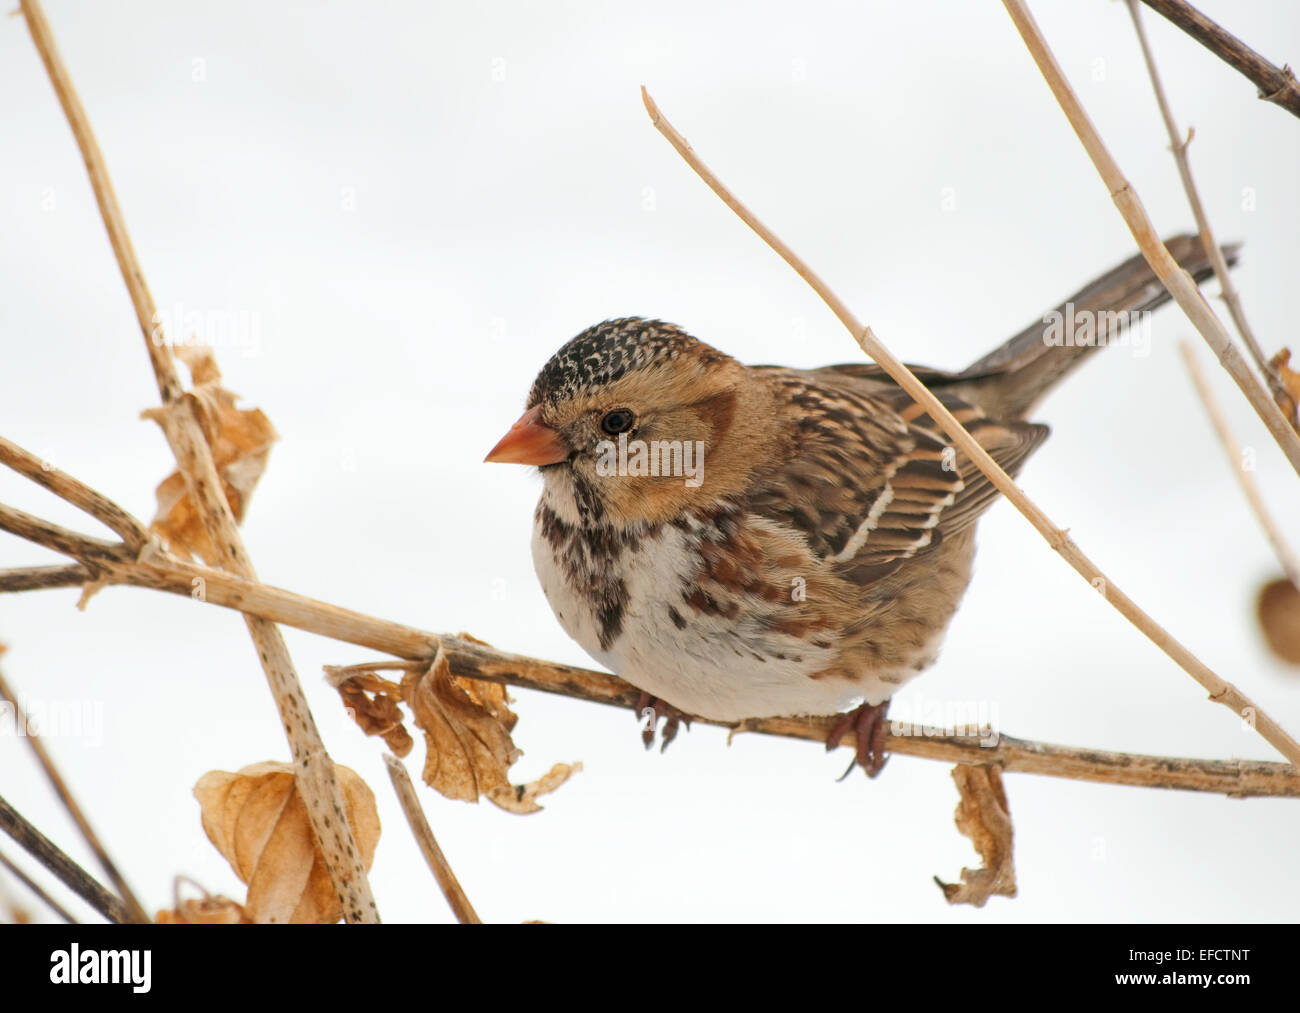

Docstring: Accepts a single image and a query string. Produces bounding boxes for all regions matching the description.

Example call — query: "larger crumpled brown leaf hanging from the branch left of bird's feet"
[402,649,521,802]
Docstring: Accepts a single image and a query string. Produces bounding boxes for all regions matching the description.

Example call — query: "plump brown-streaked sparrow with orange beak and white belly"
[486,237,1236,776]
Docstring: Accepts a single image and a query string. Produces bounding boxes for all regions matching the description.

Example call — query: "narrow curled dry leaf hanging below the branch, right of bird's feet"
[935,763,1015,908]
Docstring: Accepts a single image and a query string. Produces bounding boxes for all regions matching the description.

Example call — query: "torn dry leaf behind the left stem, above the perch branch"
[143,345,278,563]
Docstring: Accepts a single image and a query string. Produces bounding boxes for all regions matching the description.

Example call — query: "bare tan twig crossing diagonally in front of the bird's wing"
[641,88,1300,765]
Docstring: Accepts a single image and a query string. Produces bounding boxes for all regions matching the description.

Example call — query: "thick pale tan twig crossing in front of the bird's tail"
[1002,0,1300,475]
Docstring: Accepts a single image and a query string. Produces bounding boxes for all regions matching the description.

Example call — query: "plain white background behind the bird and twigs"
[0,0,1300,923]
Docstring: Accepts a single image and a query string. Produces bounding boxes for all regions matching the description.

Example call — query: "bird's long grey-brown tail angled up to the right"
[954,235,1239,417]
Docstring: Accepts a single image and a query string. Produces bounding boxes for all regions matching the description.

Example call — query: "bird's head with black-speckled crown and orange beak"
[486,317,766,524]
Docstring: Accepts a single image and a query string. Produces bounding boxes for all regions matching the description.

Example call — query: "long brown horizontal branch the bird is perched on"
[0,451,1300,798]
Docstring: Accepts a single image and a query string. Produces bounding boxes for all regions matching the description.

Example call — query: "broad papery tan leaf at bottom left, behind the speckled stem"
[194,762,380,925]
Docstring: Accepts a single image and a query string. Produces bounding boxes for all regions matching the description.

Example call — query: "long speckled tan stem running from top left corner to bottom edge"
[21,0,378,922]
